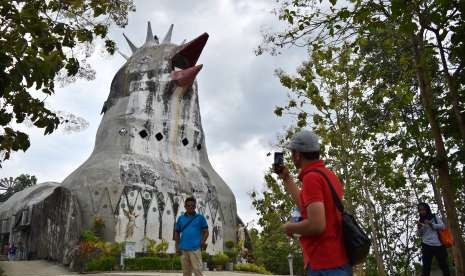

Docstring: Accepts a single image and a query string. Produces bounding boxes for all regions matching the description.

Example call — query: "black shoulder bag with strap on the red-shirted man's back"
[311,169,371,265]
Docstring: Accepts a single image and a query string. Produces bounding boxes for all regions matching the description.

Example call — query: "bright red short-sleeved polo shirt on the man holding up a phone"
[299,160,348,270]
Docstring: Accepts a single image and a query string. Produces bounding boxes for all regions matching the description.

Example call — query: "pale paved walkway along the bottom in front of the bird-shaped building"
[0,260,263,276]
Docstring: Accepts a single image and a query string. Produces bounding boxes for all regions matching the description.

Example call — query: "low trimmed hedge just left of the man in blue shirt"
[124,256,182,270]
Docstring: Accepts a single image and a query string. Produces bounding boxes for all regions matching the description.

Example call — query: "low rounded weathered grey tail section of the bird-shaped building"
[0,182,82,262]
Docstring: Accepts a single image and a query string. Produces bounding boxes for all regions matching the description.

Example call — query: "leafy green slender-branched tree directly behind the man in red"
[275,38,446,275]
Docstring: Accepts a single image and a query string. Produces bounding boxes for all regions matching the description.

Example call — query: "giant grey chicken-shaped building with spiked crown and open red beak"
[0,23,239,264]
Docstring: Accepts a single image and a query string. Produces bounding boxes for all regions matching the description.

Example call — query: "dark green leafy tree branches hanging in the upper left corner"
[0,0,134,166]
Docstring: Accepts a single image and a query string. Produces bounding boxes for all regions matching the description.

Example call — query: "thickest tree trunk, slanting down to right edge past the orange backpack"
[411,30,465,275]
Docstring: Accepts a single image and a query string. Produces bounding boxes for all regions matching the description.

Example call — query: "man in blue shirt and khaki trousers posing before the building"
[174,197,208,276]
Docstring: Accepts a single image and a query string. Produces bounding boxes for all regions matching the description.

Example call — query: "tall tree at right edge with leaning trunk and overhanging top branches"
[257,0,465,275]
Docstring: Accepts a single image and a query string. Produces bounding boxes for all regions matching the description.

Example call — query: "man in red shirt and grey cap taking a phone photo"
[275,130,352,276]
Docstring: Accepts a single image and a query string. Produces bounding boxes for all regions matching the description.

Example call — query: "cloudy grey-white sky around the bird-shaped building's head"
[0,0,305,227]
